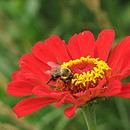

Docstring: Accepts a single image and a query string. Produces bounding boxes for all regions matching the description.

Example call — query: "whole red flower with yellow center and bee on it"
[8,30,130,117]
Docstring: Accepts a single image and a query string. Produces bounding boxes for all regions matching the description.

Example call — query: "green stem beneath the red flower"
[82,104,96,130]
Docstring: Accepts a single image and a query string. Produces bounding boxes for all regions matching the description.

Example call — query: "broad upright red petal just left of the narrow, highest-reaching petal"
[68,31,94,59]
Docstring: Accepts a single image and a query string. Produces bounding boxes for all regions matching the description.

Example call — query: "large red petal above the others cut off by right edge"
[108,36,130,78]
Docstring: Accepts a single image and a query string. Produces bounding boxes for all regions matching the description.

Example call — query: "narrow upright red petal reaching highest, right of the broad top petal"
[95,29,115,61]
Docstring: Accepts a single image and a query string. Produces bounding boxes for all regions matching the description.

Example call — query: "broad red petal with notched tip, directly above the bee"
[32,35,70,63]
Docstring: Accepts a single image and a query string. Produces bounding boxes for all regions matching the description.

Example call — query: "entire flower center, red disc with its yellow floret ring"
[61,56,111,89]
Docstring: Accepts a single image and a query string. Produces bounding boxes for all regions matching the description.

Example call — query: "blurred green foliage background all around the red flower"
[0,0,130,130]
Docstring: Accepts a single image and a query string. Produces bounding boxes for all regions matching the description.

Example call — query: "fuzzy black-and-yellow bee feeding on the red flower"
[47,67,73,84]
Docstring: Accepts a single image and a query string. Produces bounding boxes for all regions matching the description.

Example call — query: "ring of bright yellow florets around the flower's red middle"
[61,56,111,87]
